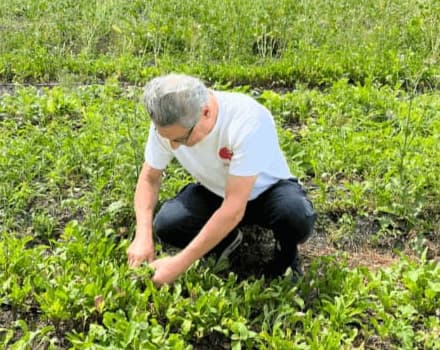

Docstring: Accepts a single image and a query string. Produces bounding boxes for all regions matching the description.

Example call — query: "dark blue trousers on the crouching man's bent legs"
[154,179,316,274]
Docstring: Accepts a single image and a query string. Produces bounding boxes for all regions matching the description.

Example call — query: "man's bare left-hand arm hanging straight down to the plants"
[127,163,163,267]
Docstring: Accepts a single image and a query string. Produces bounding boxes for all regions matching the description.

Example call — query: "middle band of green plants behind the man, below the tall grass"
[0,80,440,243]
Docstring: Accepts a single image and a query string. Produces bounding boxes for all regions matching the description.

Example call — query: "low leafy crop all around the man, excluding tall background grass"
[0,80,440,349]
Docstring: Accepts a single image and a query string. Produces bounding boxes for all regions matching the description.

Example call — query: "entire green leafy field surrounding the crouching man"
[0,0,440,350]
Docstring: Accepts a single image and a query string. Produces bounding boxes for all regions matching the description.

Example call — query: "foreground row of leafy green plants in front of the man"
[0,222,440,349]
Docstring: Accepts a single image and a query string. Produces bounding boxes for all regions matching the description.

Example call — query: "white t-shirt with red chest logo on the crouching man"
[145,91,292,200]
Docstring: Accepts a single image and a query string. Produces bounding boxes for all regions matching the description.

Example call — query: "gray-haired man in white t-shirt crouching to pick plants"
[127,74,316,285]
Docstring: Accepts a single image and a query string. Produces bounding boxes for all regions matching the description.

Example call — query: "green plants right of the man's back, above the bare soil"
[259,80,440,223]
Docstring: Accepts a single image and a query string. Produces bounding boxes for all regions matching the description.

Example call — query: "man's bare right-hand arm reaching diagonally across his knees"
[152,175,257,285]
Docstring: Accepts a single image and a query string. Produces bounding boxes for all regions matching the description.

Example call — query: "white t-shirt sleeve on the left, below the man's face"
[145,123,174,170]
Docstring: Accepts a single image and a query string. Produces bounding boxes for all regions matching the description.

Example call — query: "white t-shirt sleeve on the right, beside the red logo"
[229,109,279,176]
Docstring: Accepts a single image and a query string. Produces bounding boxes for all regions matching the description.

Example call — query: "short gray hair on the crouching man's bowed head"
[143,73,209,128]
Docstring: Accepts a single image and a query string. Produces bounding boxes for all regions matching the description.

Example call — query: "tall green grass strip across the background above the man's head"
[0,0,440,89]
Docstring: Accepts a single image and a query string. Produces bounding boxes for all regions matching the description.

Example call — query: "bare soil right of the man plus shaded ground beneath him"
[225,212,440,279]
